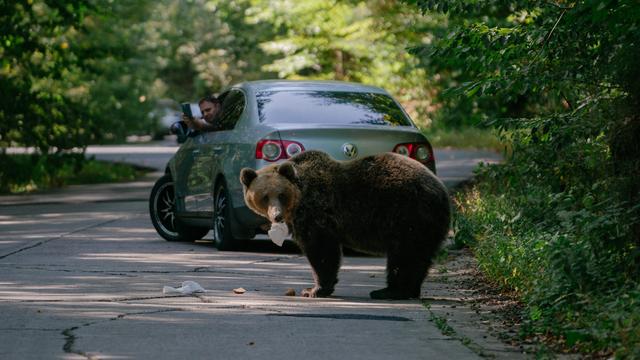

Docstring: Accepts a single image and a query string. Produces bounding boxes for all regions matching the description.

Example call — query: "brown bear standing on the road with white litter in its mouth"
[240,151,450,299]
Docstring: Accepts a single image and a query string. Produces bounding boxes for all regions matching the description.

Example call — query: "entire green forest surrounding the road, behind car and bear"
[0,0,640,357]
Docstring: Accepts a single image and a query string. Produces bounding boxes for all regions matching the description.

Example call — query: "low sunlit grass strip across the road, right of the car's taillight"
[423,127,504,151]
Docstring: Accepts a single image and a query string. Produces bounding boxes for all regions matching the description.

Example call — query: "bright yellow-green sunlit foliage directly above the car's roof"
[247,0,433,127]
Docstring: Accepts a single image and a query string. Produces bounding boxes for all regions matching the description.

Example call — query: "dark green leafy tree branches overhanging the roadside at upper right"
[413,0,640,231]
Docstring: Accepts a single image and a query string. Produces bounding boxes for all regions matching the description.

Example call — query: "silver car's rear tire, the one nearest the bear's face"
[213,183,239,251]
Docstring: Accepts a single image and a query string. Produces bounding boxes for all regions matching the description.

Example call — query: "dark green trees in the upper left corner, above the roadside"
[0,0,160,149]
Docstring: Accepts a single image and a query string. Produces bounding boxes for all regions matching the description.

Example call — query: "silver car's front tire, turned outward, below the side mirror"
[149,174,209,241]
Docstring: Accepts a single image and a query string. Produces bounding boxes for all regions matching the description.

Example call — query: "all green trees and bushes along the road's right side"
[409,0,640,356]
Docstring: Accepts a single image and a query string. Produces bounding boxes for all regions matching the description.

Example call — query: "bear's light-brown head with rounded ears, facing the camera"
[240,162,300,223]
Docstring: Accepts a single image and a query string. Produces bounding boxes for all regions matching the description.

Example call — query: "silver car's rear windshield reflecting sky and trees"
[257,90,411,126]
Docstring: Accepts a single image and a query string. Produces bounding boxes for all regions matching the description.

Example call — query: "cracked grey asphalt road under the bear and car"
[0,145,510,359]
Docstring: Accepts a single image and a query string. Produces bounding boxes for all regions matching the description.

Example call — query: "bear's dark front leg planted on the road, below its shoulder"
[299,238,342,297]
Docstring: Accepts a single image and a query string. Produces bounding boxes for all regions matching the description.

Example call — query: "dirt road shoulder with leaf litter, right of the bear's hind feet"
[422,249,536,359]
